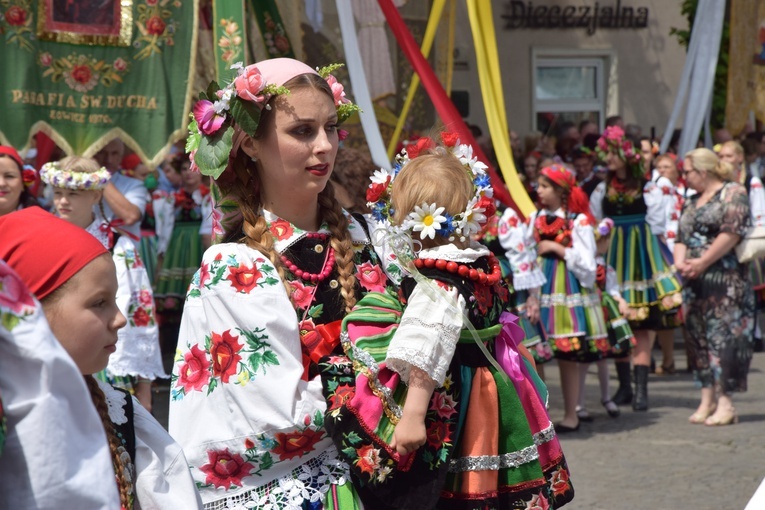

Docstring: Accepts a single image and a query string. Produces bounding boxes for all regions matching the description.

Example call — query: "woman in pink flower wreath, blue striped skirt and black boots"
[590,126,682,411]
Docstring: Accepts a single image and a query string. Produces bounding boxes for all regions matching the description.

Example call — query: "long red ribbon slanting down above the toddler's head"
[378,0,520,212]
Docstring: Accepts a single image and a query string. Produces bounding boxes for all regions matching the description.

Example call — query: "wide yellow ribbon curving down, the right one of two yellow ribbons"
[467,0,536,217]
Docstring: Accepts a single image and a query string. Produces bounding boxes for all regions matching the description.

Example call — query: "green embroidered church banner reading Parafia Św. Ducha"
[0,0,198,164]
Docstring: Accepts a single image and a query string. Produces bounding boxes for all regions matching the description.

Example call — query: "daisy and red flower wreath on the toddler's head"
[367,133,496,242]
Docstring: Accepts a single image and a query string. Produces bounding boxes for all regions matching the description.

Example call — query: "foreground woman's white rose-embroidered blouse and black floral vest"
[169,211,388,509]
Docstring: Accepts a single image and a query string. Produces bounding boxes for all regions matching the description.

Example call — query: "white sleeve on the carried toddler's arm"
[386,282,465,386]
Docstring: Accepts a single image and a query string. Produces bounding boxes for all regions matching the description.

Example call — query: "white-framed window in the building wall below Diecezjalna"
[531,51,607,134]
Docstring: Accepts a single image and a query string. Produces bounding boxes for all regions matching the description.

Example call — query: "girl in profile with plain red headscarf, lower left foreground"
[0,207,202,510]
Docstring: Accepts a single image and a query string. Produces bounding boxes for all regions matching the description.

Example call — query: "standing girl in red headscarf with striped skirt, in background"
[510,164,608,433]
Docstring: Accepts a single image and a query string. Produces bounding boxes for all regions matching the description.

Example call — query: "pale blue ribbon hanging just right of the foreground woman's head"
[335,0,392,168]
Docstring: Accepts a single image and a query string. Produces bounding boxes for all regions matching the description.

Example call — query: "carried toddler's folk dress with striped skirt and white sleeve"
[318,244,573,509]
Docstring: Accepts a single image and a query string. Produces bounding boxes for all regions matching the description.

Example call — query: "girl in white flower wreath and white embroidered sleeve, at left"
[40,156,167,411]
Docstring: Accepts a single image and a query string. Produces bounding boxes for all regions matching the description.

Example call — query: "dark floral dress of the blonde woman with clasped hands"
[678,183,755,394]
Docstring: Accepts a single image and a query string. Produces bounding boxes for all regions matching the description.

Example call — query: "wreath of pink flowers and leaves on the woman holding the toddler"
[186,62,360,179]
